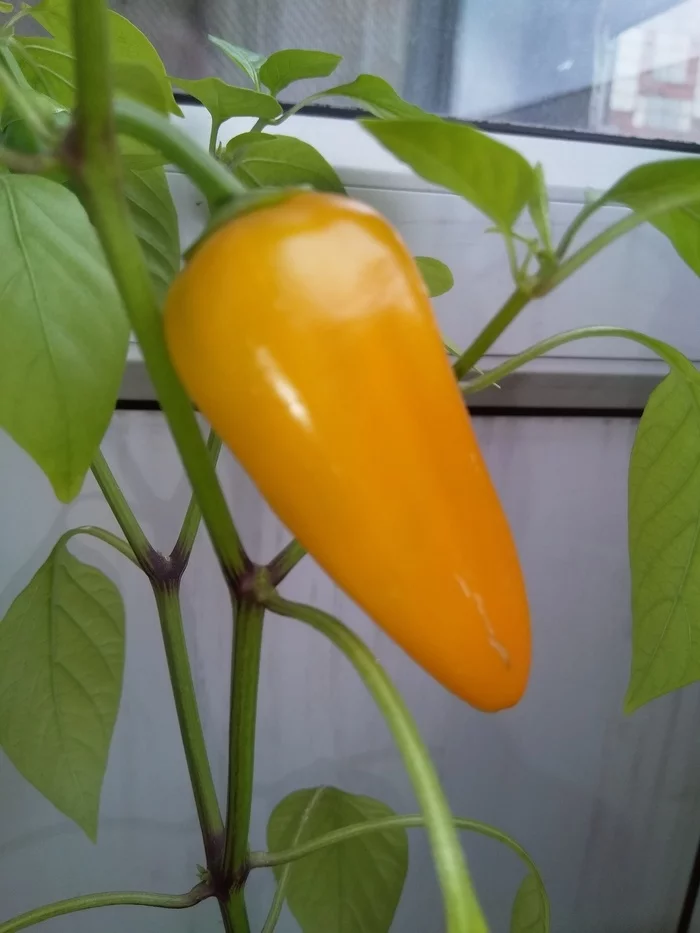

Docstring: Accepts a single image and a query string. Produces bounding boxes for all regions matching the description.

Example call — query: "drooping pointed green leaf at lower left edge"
[0,542,124,841]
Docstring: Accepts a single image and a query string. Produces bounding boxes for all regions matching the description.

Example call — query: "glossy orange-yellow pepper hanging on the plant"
[165,192,530,710]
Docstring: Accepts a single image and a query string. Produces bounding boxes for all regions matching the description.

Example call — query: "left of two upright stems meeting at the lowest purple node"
[153,587,224,871]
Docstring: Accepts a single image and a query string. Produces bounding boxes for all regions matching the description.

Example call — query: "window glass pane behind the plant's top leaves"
[20,0,700,141]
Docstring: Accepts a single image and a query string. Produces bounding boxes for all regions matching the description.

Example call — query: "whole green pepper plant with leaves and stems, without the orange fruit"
[0,0,700,933]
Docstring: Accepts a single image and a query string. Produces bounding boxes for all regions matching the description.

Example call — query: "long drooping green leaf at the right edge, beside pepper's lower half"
[625,365,700,712]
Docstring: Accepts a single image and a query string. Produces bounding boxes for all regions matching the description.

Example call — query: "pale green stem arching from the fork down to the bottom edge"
[264,591,487,933]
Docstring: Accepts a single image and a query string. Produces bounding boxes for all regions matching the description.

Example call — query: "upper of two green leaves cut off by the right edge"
[596,159,700,275]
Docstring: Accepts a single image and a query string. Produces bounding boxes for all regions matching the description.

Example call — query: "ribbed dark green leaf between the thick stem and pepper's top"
[124,168,180,301]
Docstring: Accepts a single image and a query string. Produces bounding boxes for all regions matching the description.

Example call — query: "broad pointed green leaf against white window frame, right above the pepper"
[361,119,534,230]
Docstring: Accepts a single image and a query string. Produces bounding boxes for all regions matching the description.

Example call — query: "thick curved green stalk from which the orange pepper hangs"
[113,97,247,205]
